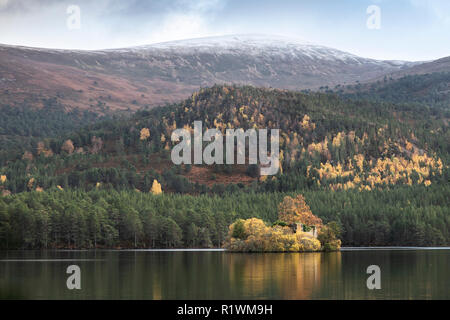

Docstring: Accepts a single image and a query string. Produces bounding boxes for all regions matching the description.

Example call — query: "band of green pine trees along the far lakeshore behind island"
[0,185,450,249]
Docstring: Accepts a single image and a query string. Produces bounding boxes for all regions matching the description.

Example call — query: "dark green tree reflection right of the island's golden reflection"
[312,250,450,299]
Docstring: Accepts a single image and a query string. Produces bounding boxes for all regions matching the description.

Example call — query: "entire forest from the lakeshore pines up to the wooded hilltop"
[0,74,450,248]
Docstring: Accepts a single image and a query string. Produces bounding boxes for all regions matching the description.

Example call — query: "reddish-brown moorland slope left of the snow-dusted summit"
[0,46,194,112]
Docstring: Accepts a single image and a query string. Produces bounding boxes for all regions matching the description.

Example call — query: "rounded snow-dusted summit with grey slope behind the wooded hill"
[108,35,412,89]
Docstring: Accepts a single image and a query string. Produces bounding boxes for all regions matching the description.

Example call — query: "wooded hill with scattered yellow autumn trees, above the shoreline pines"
[1,86,450,193]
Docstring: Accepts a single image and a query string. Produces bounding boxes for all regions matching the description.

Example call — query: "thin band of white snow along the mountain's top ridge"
[0,34,418,68]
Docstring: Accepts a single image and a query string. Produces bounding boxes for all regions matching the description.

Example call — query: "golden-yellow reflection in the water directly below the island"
[230,252,340,299]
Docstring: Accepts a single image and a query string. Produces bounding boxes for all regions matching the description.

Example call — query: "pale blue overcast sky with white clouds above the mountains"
[0,0,450,61]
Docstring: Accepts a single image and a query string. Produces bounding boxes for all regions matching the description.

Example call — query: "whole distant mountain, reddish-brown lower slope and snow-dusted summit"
[0,35,414,111]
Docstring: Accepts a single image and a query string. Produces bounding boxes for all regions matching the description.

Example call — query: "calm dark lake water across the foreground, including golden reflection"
[0,249,450,299]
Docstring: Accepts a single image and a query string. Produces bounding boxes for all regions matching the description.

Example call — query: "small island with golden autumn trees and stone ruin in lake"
[224,195,341,252]
